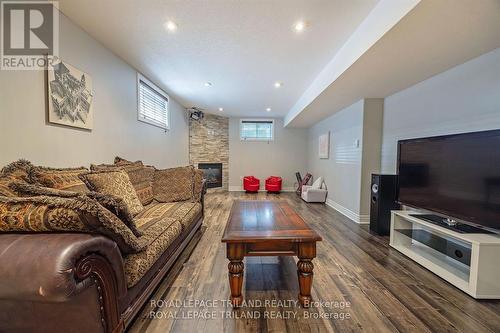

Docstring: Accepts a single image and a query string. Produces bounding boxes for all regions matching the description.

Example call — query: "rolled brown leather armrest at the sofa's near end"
[0,233,127,302]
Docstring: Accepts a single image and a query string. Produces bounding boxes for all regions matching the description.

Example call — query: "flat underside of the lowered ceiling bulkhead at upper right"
[285,0,500,127]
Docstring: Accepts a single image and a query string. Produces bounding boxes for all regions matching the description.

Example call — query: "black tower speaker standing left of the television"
[370,174,400,236]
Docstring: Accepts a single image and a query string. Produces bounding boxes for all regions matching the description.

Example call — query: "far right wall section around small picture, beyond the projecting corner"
[307,100,364,218]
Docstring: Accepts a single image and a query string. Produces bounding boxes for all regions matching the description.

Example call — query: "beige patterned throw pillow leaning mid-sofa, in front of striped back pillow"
[80,170,144,216]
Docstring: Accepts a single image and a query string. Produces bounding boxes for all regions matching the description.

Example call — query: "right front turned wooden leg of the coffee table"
[297,243,316,308]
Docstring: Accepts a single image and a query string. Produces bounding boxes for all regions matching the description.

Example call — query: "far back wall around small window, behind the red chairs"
[229,118,307,190]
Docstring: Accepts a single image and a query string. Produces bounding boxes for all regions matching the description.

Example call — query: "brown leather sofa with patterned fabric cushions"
[0,159,205,332]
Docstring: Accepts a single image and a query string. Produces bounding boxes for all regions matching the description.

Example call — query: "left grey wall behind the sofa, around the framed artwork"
[0,15,189,168]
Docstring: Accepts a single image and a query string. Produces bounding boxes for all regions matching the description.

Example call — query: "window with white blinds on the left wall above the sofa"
[137,73,170,130]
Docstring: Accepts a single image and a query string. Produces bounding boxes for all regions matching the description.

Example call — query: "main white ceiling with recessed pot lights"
[59,0,378,117]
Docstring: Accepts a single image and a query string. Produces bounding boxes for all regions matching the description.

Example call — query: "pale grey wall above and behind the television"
[382,48,500,173]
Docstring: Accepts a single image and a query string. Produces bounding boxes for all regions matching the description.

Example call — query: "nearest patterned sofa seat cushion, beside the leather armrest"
[123,217,182,288]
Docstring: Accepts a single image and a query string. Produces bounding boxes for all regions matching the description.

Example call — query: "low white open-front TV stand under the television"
[390,211,500,299]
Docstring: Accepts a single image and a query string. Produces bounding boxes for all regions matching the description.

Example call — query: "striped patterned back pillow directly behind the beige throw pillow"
[90,161,155,206]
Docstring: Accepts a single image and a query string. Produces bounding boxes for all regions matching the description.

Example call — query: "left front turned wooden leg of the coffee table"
[226,243,244,307]
